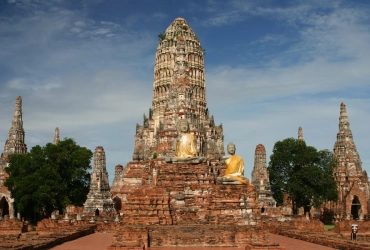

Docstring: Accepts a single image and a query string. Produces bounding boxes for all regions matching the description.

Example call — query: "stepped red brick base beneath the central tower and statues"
[111,159,265,247]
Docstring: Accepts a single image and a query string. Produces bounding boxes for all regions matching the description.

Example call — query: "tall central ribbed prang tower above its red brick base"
[133,17,224,161]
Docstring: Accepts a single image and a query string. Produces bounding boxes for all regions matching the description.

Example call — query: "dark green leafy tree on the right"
[268,138,338,212]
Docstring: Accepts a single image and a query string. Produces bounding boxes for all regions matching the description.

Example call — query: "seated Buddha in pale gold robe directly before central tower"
[166,119,205,163]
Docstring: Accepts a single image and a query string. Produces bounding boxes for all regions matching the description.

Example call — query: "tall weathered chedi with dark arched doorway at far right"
[330,103,369,219]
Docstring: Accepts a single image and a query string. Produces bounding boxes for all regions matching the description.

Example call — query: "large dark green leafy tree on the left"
[5,138,92,220]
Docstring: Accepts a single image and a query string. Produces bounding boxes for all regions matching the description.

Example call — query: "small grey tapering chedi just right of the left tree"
[83,146,115,215]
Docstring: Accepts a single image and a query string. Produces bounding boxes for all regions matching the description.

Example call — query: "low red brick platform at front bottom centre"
[109,225,267,249]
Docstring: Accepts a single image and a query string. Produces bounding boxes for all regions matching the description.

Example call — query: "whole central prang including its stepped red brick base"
[111,18,264,249]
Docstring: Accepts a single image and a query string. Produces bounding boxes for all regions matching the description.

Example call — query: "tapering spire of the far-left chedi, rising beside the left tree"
[2,96,27,159]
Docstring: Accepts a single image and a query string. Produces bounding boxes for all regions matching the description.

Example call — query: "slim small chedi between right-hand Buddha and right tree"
[252,144,276,212]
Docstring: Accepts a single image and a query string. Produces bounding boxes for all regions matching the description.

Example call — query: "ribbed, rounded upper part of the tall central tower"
[153,17,206,112]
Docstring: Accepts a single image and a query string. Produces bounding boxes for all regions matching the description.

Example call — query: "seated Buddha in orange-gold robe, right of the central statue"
[217,142,250,186]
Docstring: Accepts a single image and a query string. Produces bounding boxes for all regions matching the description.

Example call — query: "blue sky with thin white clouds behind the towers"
[0,0,370,184]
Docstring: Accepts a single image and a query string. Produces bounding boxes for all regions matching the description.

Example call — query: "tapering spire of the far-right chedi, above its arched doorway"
[334,102,362,175]
